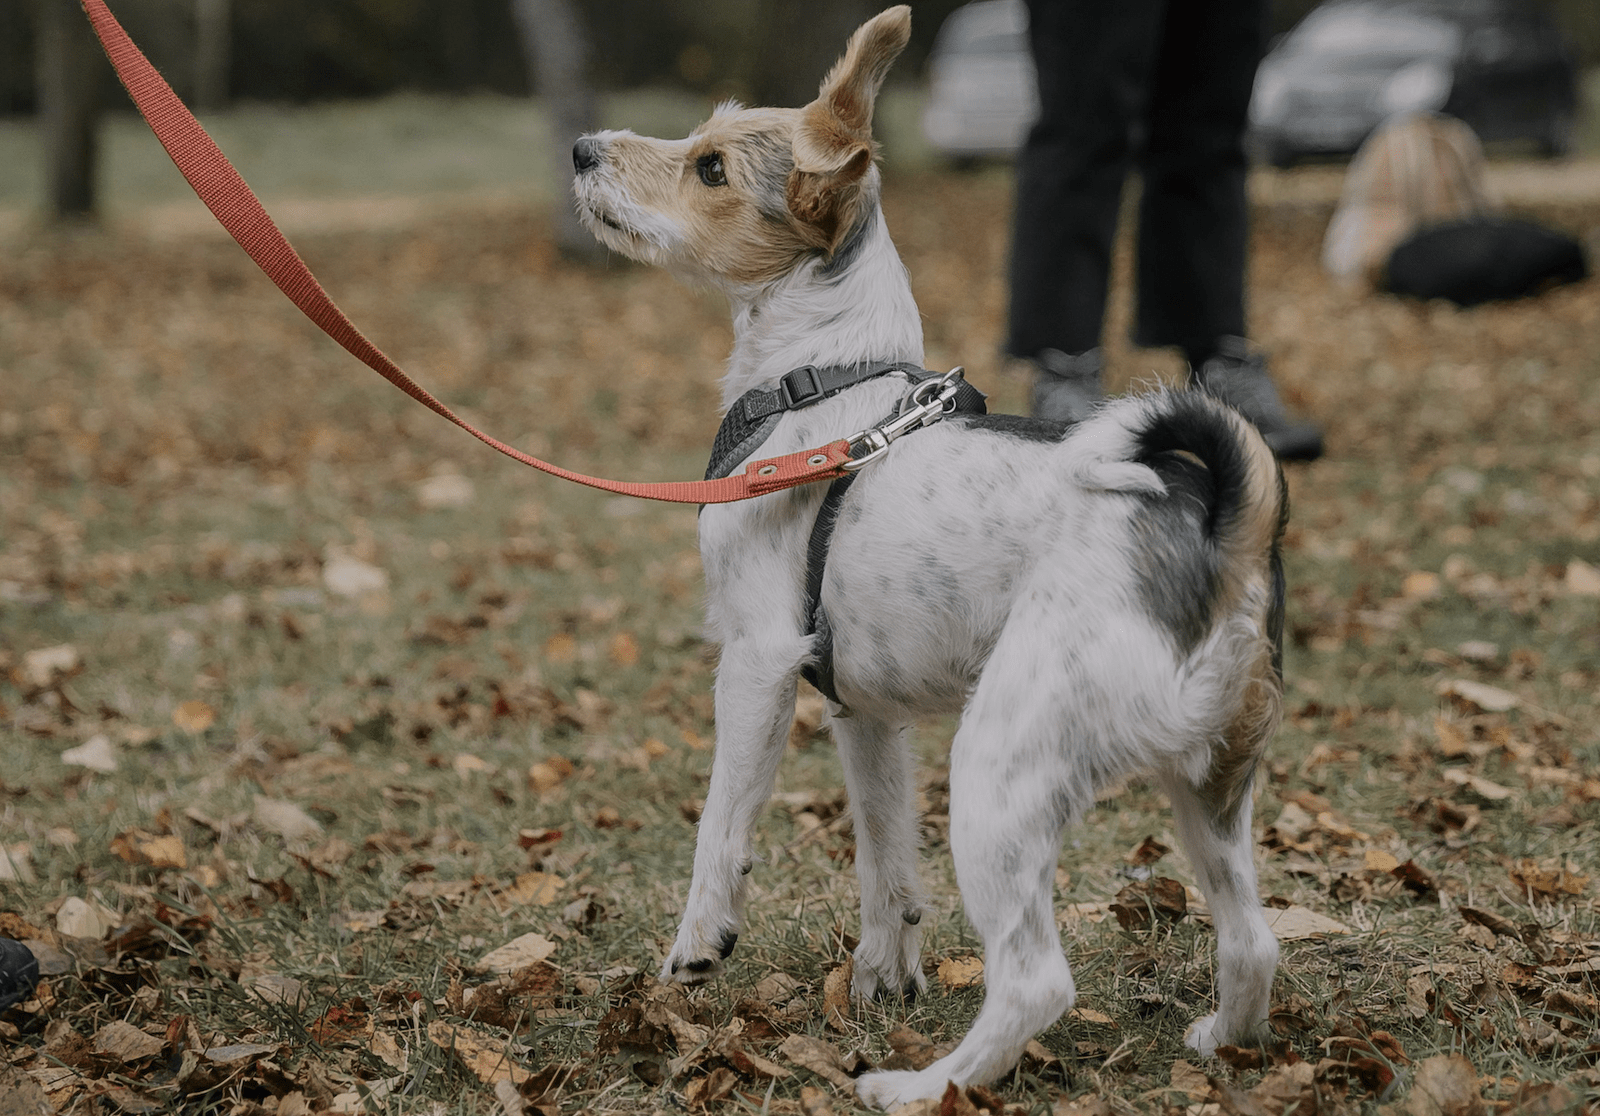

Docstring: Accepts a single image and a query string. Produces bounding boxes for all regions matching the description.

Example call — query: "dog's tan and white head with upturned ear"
[573,5,910,286]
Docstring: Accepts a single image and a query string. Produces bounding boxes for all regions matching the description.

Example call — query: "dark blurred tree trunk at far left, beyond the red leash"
[34,0,106,221]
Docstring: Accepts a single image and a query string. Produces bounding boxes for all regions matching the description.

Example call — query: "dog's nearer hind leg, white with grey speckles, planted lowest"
[856,638,1093,1108]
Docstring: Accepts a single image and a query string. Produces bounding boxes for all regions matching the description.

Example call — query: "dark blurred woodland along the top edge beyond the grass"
[0,0,1600,213]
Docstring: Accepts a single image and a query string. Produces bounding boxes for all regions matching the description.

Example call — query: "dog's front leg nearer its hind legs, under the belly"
[830,715,926,999]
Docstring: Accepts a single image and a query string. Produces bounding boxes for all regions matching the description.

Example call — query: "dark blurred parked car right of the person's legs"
[1250,0,1578,166]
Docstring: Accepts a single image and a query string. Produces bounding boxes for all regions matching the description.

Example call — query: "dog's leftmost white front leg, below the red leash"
[661,636,810,983]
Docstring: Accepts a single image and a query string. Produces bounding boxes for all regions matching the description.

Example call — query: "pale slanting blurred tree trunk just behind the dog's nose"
[512,0,605,261]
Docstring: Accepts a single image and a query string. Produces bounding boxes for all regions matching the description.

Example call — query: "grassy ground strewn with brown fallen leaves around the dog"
[0,158,1600,1116]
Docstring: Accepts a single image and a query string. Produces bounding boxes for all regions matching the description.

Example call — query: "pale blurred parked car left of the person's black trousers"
[922,0,1038,158]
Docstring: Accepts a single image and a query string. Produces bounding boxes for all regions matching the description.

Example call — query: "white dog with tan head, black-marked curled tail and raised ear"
[573,6,1286,1108]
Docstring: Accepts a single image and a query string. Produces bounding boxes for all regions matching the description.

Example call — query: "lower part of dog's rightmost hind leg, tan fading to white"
[1163,774,1278,1055]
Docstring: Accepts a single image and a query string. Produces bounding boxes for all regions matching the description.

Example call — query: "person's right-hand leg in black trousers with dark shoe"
[1136,0,1322,460]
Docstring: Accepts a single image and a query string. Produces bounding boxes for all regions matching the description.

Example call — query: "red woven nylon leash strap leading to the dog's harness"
[82,0,850,504]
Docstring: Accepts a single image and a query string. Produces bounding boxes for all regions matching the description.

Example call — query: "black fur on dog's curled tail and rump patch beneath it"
[1133,393,1250,656]
